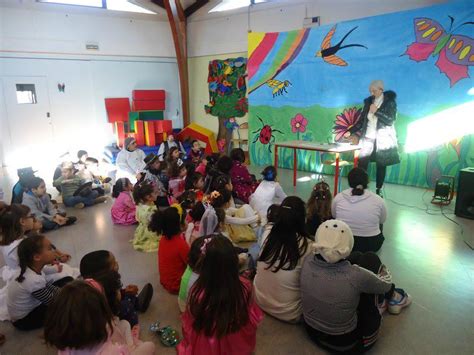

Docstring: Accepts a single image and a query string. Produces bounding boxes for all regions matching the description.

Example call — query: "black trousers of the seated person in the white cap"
[305,252,395,354]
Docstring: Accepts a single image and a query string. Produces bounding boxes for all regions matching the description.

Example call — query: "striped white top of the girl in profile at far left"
[7,268,46,321]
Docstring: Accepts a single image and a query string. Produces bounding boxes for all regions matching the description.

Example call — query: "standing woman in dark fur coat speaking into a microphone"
[355,80,400,195]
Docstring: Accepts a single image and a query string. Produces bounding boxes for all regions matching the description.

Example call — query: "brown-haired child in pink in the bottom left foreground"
[44,279,155,355]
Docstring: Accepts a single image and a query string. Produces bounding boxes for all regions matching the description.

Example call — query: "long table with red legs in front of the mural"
[275,140,360,196]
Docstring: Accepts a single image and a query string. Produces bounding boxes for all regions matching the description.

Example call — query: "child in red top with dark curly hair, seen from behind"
[149,207,189,293]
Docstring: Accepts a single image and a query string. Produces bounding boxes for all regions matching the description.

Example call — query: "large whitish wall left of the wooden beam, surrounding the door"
[0,0,182,165]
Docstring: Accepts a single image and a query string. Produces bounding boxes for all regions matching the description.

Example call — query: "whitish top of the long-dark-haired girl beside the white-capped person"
[253,241,310,323]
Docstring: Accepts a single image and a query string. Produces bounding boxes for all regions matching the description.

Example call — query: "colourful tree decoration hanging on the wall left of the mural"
[204,57,248,151]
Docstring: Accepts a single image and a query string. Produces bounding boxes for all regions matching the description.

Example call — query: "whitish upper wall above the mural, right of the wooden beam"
[188,0,447,57]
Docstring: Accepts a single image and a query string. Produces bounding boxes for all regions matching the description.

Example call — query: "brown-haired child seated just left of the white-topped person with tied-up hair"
[306,181,332,238]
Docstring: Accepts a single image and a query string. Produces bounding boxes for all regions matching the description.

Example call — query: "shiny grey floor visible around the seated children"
[0,167,474,355]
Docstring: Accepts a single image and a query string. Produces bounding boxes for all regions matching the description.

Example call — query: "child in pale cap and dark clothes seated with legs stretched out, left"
[53,163,107,208]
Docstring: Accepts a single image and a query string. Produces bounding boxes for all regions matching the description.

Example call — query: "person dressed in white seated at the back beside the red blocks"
[116,137,146,183]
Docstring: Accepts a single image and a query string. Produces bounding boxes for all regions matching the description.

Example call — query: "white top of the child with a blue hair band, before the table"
[249,180,286,224]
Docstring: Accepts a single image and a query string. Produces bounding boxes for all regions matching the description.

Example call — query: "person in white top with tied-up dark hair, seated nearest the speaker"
[331,168,387,253]
